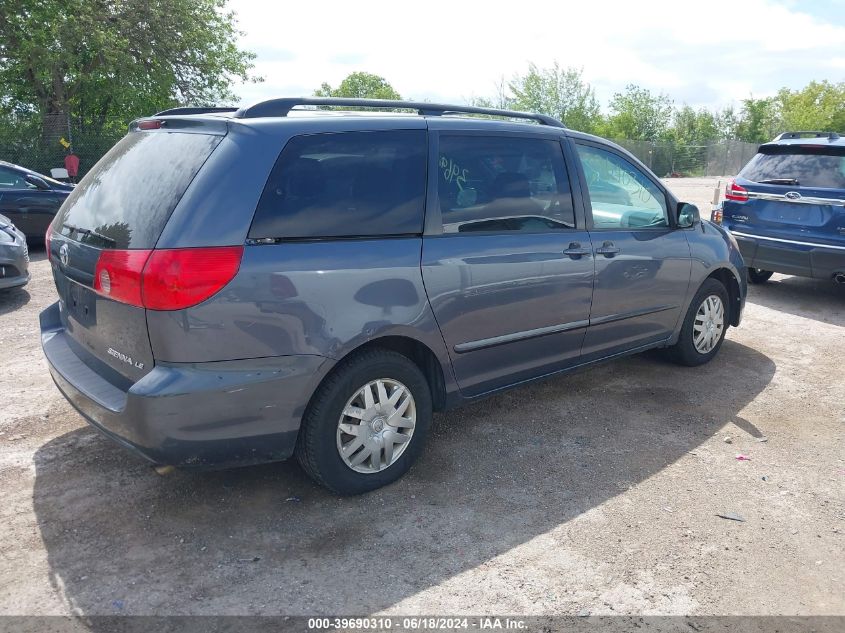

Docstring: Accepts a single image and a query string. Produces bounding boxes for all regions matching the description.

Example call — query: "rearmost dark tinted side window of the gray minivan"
[249,130,426,239]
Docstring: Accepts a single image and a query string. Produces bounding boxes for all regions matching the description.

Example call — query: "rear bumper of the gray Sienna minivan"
[41,304,333,468]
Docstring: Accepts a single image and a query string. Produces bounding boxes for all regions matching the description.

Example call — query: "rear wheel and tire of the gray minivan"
[296,349,432,495]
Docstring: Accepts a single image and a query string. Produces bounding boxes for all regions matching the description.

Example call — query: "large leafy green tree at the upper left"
[0,0,254,136]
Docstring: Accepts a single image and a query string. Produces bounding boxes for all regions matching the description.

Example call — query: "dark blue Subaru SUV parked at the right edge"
[714,132,845,284]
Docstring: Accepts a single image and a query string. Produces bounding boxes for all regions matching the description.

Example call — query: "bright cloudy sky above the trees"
[228,0,845,108]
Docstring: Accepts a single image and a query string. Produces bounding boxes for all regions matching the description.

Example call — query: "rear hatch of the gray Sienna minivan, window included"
[47,120,225,382]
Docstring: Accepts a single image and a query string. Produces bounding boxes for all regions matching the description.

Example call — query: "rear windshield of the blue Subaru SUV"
[739,147,845,189]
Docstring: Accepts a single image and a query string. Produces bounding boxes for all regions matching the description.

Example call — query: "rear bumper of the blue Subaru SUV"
[729,228,845,279]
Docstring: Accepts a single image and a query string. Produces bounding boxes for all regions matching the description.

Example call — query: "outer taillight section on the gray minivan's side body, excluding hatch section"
[143,246,244,310]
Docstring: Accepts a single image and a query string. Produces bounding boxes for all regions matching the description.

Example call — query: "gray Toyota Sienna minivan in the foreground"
[41,98,746,494]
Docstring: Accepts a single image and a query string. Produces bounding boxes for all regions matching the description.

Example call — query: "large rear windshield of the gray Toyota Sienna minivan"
[53,132,222,249]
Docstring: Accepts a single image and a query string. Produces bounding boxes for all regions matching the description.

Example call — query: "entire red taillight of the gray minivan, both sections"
[94,246,243,310]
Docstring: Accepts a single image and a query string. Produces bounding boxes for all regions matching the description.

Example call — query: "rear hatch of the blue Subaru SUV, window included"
[726,144,845,245]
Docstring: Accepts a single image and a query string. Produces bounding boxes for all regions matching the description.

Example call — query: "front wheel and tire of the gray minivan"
[667,278,730,367]
